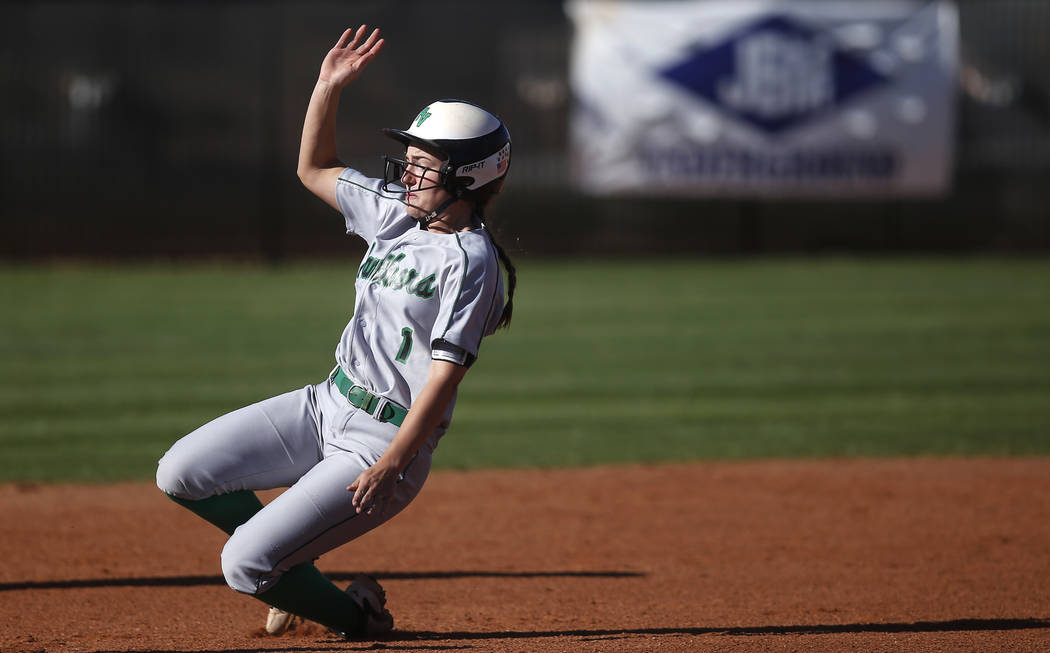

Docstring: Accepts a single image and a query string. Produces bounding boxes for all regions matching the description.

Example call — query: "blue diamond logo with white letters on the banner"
[659,16,889,134]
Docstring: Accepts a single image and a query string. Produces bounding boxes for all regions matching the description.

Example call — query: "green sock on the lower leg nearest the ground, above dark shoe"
[255,563,364,634]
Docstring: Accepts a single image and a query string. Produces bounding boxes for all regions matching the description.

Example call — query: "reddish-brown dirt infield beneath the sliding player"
[0,459,1050,653]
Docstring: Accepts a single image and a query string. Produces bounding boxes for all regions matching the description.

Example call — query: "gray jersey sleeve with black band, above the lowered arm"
[431,235,503,366]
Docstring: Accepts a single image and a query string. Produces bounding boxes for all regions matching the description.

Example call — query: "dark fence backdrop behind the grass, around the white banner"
[0,0,1050,260]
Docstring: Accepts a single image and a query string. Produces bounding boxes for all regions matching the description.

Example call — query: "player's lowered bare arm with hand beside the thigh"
[347,360,467,514]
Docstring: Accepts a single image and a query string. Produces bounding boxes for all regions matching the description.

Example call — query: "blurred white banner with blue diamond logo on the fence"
[566,0,959,196]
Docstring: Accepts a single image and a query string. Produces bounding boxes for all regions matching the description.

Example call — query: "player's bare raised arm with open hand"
[298,25,384,209]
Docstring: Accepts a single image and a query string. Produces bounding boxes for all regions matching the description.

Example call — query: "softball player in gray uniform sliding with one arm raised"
[156,25,516,636]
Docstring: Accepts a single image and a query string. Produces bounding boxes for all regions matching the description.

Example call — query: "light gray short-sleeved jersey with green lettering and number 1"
[335,168,503,432]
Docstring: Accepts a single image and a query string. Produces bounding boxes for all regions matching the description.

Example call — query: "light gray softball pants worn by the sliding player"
[156,373,433,594]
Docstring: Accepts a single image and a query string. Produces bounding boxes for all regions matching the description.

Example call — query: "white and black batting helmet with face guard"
[383,100,510,194]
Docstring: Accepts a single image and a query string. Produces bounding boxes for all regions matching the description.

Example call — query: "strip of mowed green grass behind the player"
[0,259,1050,481]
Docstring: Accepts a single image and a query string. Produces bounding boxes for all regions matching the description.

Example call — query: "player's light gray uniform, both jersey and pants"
[156,169,503,594]
